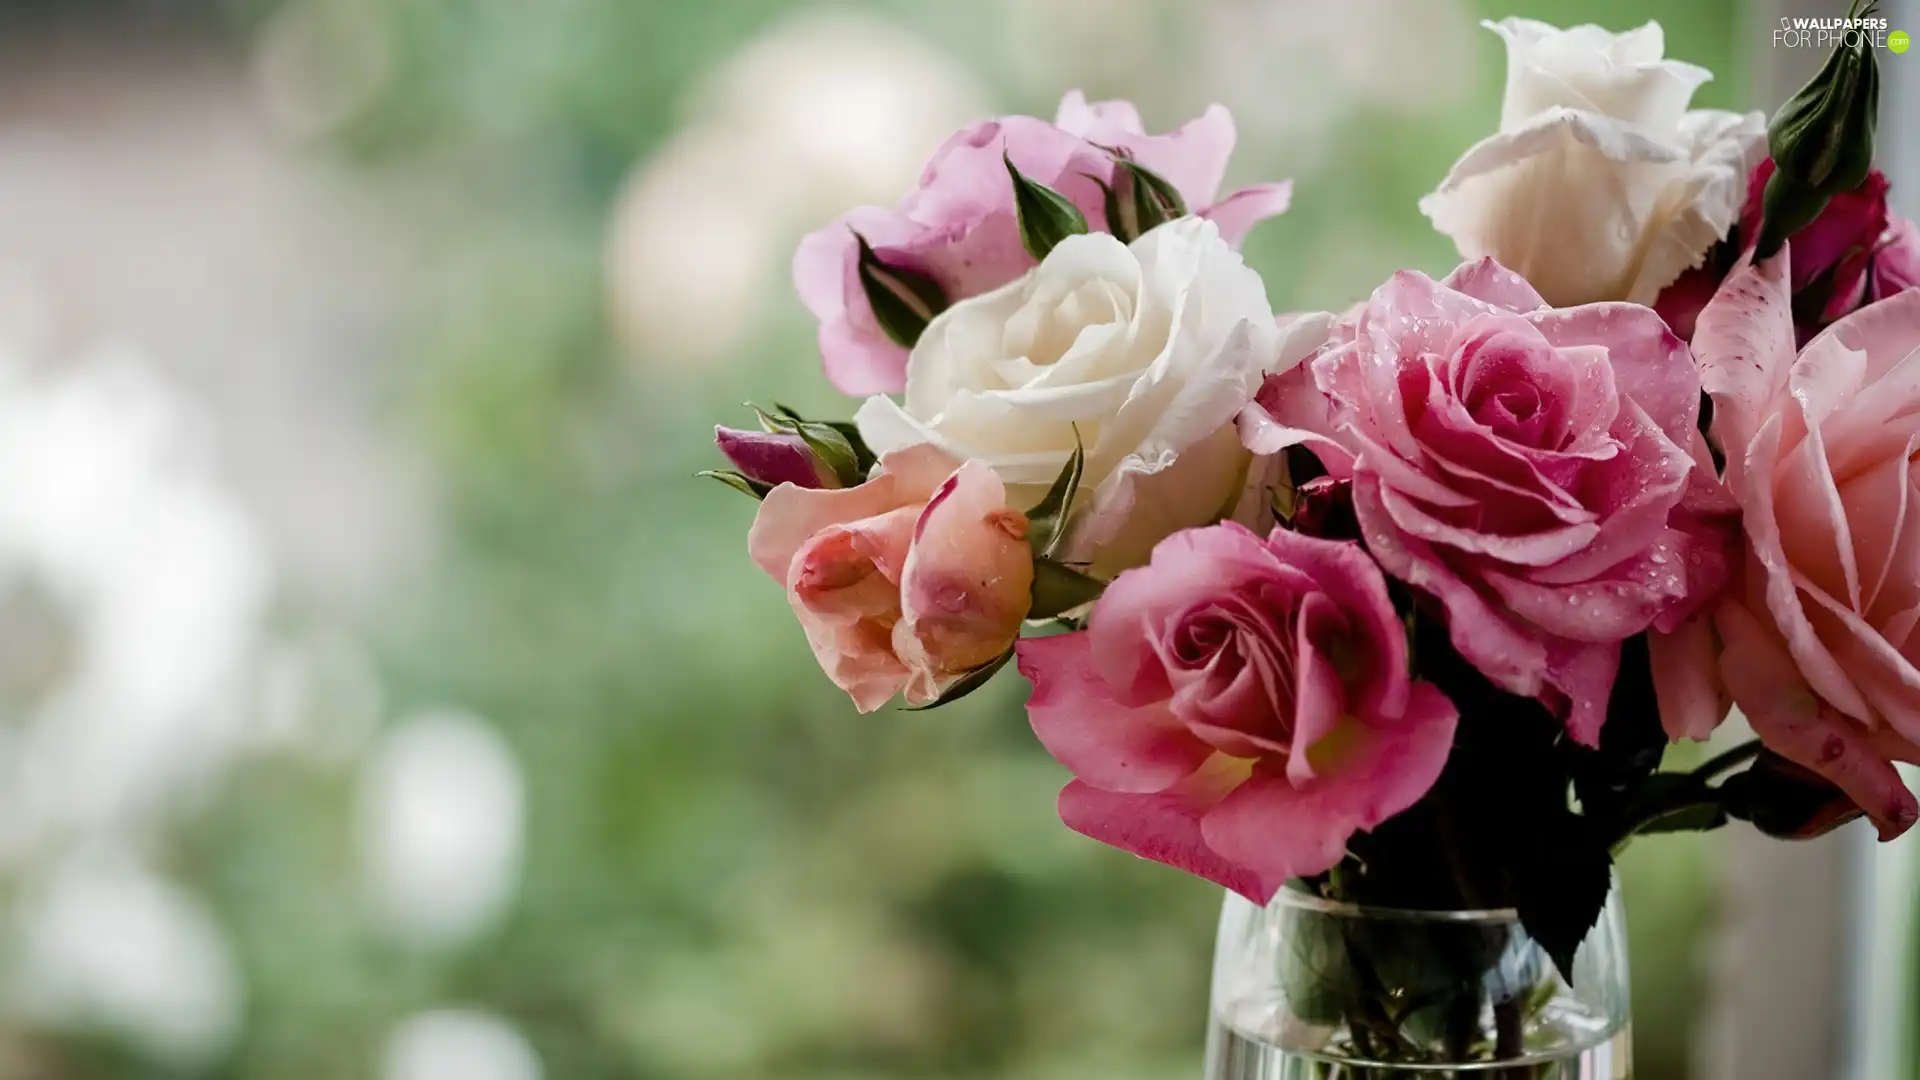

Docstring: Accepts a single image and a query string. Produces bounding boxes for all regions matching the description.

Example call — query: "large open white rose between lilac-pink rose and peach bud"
[854,217,1327,575]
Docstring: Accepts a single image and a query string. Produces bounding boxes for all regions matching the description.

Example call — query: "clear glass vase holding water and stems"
[1206,882,1632,1080]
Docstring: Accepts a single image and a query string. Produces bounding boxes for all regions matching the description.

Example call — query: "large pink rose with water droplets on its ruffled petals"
[1240,259,1718,746]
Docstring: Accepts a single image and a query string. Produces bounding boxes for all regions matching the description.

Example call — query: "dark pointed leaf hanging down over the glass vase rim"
[1509,809,1613,982]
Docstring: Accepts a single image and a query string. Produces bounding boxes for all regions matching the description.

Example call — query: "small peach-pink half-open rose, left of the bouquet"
[747,446,1033,713]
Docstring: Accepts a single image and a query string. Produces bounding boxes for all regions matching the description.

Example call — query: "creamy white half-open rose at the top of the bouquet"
[1421,19,1766,306]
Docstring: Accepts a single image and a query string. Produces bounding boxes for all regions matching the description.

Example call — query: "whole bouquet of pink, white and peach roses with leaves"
[714,8,1920,1060]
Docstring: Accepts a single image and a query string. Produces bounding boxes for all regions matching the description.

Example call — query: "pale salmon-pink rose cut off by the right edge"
[1668,242,1920,838]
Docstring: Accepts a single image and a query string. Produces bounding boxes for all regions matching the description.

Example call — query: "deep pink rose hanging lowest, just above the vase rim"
[1020,523,1457,903]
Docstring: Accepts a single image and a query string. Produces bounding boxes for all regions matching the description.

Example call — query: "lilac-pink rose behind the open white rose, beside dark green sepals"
[793,90,1288,394]
